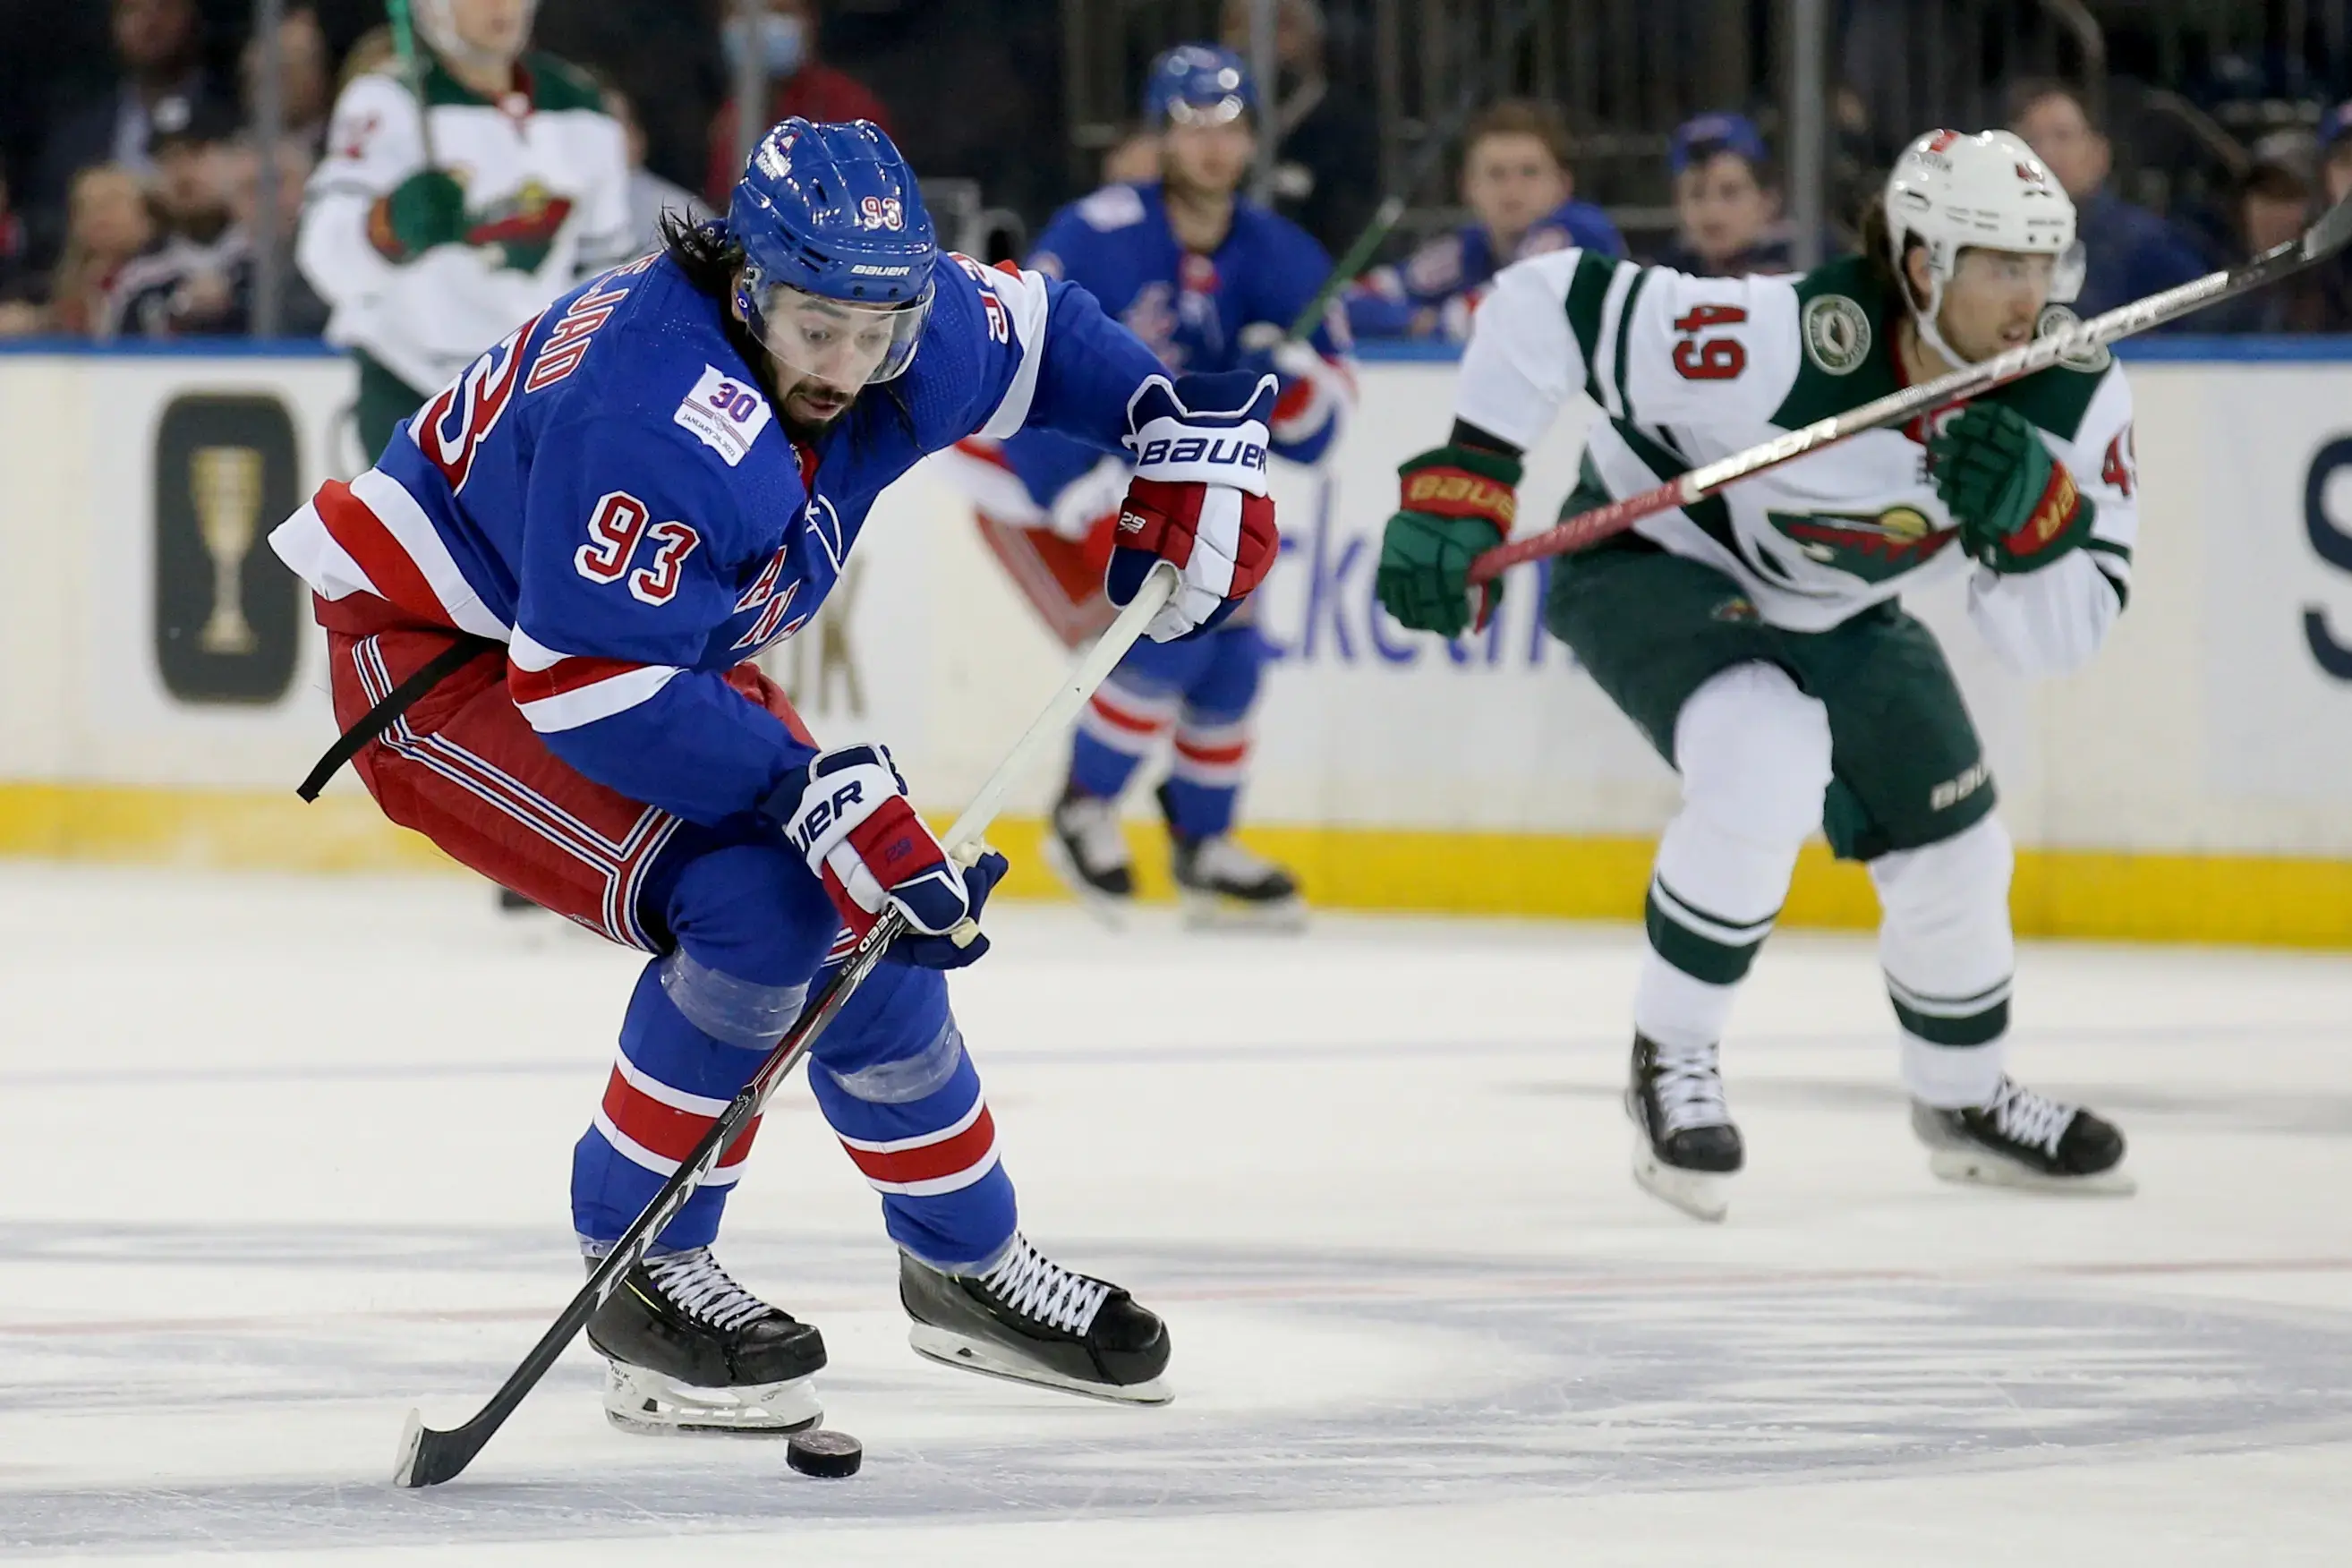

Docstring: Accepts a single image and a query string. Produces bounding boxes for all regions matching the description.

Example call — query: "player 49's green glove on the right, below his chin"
[1926,402,2098,571]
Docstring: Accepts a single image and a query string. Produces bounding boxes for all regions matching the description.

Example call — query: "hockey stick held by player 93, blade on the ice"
[393,564,1176,1486]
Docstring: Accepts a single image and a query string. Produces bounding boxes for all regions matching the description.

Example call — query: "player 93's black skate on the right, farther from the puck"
[899,1234,1172,1406]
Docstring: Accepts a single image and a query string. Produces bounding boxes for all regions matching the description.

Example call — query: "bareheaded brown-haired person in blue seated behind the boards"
[1348,98,1625,343]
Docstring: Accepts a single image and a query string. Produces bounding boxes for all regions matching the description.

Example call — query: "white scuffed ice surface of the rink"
[0,865,2352,1568]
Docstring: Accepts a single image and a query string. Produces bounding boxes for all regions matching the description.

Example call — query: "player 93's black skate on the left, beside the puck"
[588,1246,825,1436]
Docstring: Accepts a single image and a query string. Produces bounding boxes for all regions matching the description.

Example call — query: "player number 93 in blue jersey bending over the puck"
[270,120,1274,1432]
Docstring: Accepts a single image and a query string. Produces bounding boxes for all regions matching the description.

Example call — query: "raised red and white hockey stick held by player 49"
[1470,198,2352,583]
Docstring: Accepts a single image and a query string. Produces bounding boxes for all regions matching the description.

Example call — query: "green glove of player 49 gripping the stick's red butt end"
[1371,447,1520,637]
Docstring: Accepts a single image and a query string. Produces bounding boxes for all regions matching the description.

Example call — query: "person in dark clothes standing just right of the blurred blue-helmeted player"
[1221,0,1381,259]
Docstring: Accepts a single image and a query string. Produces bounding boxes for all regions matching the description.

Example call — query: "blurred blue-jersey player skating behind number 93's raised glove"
[948,45,1355,926]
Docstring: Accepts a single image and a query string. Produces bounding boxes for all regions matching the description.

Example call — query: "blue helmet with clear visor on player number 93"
[727,117,939,393]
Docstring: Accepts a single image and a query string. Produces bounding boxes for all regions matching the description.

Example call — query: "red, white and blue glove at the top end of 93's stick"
[1104,371,1282,642]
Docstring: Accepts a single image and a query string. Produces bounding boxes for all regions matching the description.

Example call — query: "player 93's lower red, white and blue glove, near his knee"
[760,746,1007,968]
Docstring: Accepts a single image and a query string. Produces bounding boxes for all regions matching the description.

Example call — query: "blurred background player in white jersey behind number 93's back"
[296,0,635,461]
